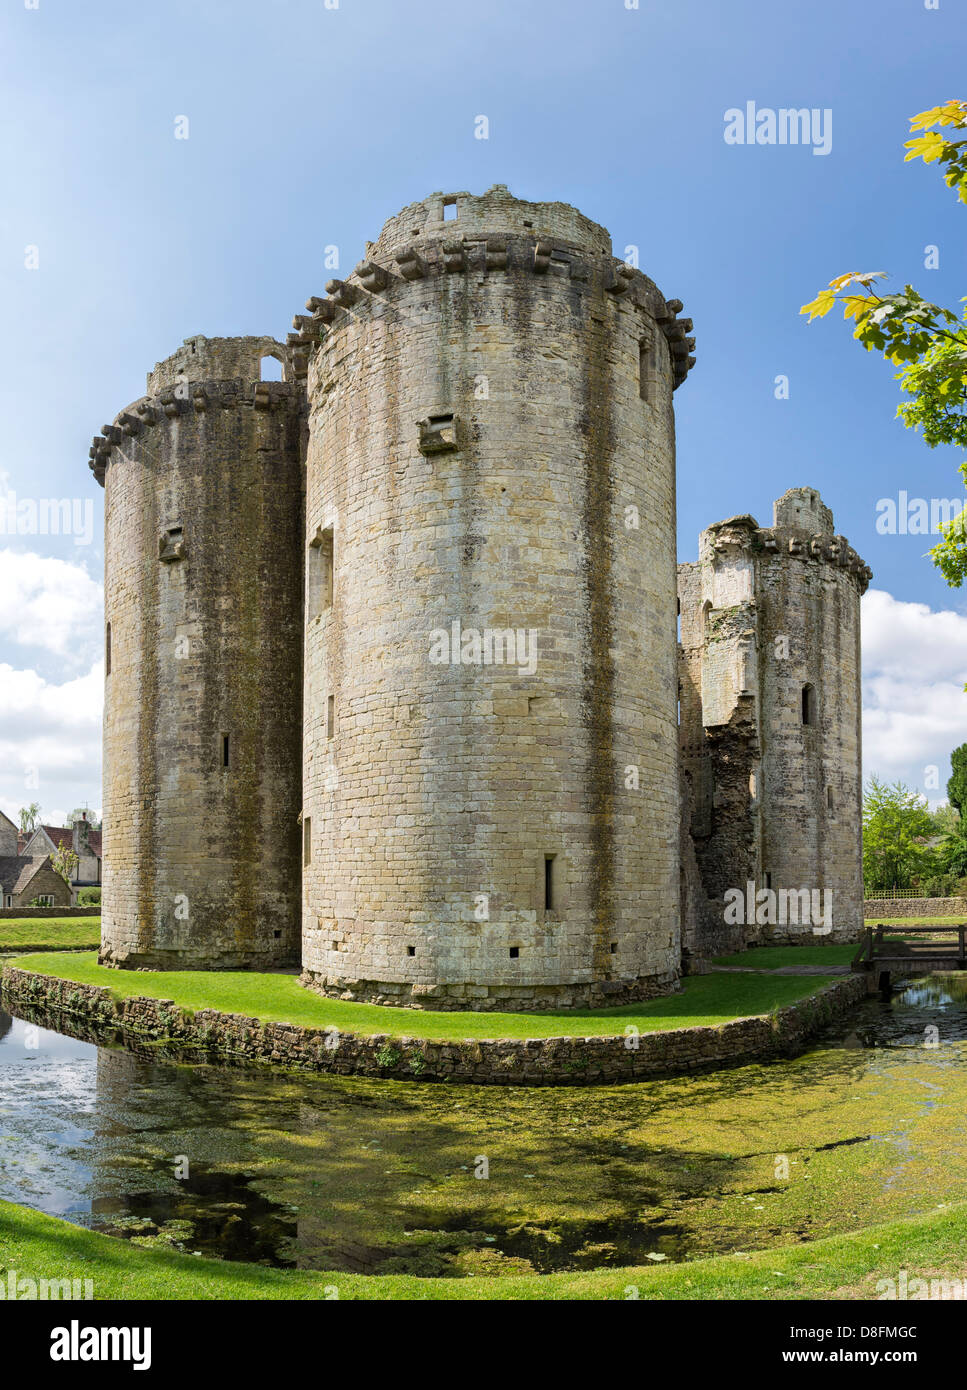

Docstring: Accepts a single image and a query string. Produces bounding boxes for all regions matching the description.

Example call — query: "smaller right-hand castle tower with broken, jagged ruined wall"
[678,488,871,947]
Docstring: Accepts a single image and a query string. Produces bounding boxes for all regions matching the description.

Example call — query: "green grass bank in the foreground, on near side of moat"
[0,1202,967,1301]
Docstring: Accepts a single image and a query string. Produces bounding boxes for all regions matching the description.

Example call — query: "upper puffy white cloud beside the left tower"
[0,549,104,661]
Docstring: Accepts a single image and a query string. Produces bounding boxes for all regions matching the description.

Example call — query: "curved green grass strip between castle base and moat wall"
[3,954,834,1038]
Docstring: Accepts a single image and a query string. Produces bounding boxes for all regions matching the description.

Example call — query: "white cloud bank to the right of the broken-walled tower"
[861,589,967,802]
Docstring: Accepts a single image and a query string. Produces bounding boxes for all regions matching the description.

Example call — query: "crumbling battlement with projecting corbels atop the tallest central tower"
[286,183,695,386]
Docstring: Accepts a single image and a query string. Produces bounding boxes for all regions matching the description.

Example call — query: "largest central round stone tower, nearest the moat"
[290,185,693,1009]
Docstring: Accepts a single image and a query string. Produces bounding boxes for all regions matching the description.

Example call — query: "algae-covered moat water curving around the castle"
[0,974,967,1276]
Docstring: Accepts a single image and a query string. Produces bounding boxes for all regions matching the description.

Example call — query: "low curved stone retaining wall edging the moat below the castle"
[3,966,867,1086]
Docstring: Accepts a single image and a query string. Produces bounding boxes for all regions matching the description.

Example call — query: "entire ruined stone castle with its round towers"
[90,185,870,1009]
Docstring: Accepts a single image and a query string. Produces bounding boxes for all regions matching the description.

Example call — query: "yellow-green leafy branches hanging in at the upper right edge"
[800,101,967,588]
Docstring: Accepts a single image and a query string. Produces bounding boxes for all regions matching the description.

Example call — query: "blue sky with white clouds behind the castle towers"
[0,0,967,816]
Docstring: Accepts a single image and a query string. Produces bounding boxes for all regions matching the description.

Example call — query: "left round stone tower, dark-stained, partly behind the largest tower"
[90,338,304,969]
